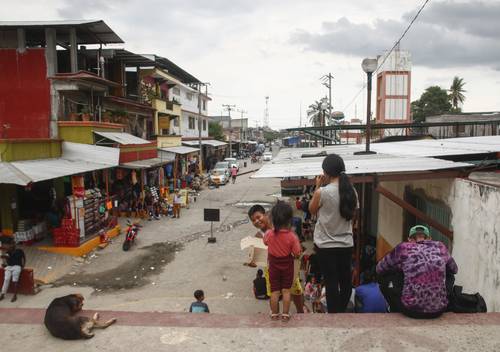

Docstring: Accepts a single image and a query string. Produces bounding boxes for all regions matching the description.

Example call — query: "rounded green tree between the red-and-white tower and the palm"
[411,86,451,122]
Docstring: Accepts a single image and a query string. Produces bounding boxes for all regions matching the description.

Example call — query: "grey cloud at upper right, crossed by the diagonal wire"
[290,1,500,69]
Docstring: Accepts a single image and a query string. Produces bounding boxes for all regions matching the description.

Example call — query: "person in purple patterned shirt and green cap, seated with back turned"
[377,225,458,319]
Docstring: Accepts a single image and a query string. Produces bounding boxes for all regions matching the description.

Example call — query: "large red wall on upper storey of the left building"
[0,49,50,138]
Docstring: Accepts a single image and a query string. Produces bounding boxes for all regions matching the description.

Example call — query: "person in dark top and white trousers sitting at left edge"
[0,241,26,302]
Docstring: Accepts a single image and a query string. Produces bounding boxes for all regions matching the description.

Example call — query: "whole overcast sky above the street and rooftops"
[0,0,500,128]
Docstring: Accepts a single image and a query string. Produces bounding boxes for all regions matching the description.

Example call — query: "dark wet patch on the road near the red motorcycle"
[53,243,183,293]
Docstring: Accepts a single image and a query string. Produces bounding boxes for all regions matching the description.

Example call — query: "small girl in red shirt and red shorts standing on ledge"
[264,201,301,321]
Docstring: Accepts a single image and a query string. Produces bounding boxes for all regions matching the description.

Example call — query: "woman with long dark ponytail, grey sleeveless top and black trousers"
[309,154,358,313]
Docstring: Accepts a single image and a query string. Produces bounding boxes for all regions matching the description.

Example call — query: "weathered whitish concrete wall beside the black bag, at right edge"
[450,179,500,312]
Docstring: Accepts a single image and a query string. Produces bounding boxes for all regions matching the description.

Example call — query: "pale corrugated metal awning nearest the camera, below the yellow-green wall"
[0,142,120,186]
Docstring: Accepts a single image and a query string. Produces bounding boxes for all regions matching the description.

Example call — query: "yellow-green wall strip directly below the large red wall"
[0,139,61,161]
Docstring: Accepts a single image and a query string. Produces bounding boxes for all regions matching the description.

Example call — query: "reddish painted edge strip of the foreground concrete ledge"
[0,308,500,329]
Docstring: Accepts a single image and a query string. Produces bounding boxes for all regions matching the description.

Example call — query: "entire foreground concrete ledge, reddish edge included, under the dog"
[0,309,500,352]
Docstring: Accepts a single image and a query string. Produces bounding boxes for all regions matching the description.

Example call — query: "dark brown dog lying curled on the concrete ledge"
[44,294,116,340]
